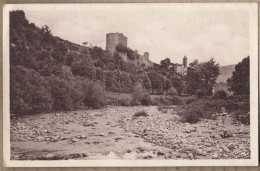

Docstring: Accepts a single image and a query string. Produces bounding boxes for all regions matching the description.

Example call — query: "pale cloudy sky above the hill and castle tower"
[21,4,249,65]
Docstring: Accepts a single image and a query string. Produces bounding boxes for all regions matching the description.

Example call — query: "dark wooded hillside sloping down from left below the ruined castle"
[10,11,182,114]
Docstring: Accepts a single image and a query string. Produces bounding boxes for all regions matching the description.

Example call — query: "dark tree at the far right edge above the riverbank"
[227,56,250,95]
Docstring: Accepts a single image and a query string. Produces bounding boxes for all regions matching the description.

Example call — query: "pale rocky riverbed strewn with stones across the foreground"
[11,106,250,160]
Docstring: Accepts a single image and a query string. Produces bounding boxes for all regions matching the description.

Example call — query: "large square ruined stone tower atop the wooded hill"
[106,33,127,53]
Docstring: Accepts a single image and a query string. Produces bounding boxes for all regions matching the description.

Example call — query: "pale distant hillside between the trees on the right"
[217,65,236,83]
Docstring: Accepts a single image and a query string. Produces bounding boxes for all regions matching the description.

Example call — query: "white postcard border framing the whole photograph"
[3,3,258,167]
